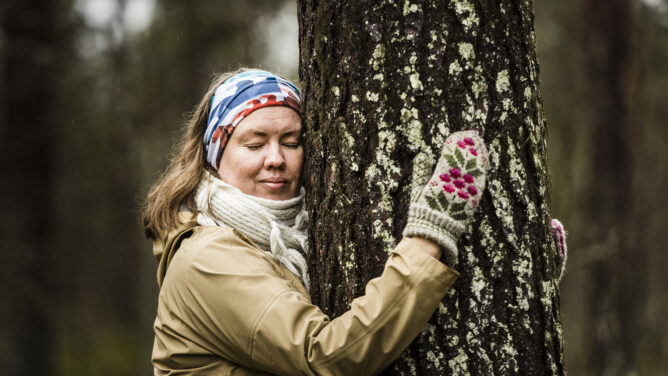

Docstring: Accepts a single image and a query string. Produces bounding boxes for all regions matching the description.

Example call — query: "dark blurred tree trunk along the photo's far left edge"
[0,0,73,375]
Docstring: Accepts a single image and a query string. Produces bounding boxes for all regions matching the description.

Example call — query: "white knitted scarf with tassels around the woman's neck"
[195,172,310,289]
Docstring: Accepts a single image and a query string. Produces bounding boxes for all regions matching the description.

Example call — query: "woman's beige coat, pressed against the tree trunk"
[153,216,458,375]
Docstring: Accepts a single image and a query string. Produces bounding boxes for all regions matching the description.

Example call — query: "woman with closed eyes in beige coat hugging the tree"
[144,70,488,375]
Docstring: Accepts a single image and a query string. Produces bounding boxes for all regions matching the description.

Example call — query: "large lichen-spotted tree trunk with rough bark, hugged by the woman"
[298,0,564,375]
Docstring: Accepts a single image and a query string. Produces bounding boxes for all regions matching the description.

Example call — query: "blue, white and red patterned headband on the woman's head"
[204,70,301,170]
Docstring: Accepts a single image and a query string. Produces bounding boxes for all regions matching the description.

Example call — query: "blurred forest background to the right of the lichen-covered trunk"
[536,0,668,375]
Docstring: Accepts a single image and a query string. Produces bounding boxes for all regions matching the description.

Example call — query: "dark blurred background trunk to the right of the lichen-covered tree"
[583,0,647,375]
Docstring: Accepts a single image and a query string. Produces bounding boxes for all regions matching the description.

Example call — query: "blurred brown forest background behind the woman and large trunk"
[0,0,668,375]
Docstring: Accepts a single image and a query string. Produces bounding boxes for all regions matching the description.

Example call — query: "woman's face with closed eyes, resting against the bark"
[218,106,304,200]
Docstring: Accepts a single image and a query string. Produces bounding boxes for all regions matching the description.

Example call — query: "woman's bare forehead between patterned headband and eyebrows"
[234,106,302,134]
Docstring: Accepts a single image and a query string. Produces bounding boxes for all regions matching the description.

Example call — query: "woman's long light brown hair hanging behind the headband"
[142,68,249,239]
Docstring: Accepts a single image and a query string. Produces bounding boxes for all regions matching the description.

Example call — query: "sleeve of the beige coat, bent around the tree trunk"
[167,229,458,375]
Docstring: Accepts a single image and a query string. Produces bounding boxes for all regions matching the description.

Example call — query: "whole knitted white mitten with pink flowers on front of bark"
[403,131,489,261]
